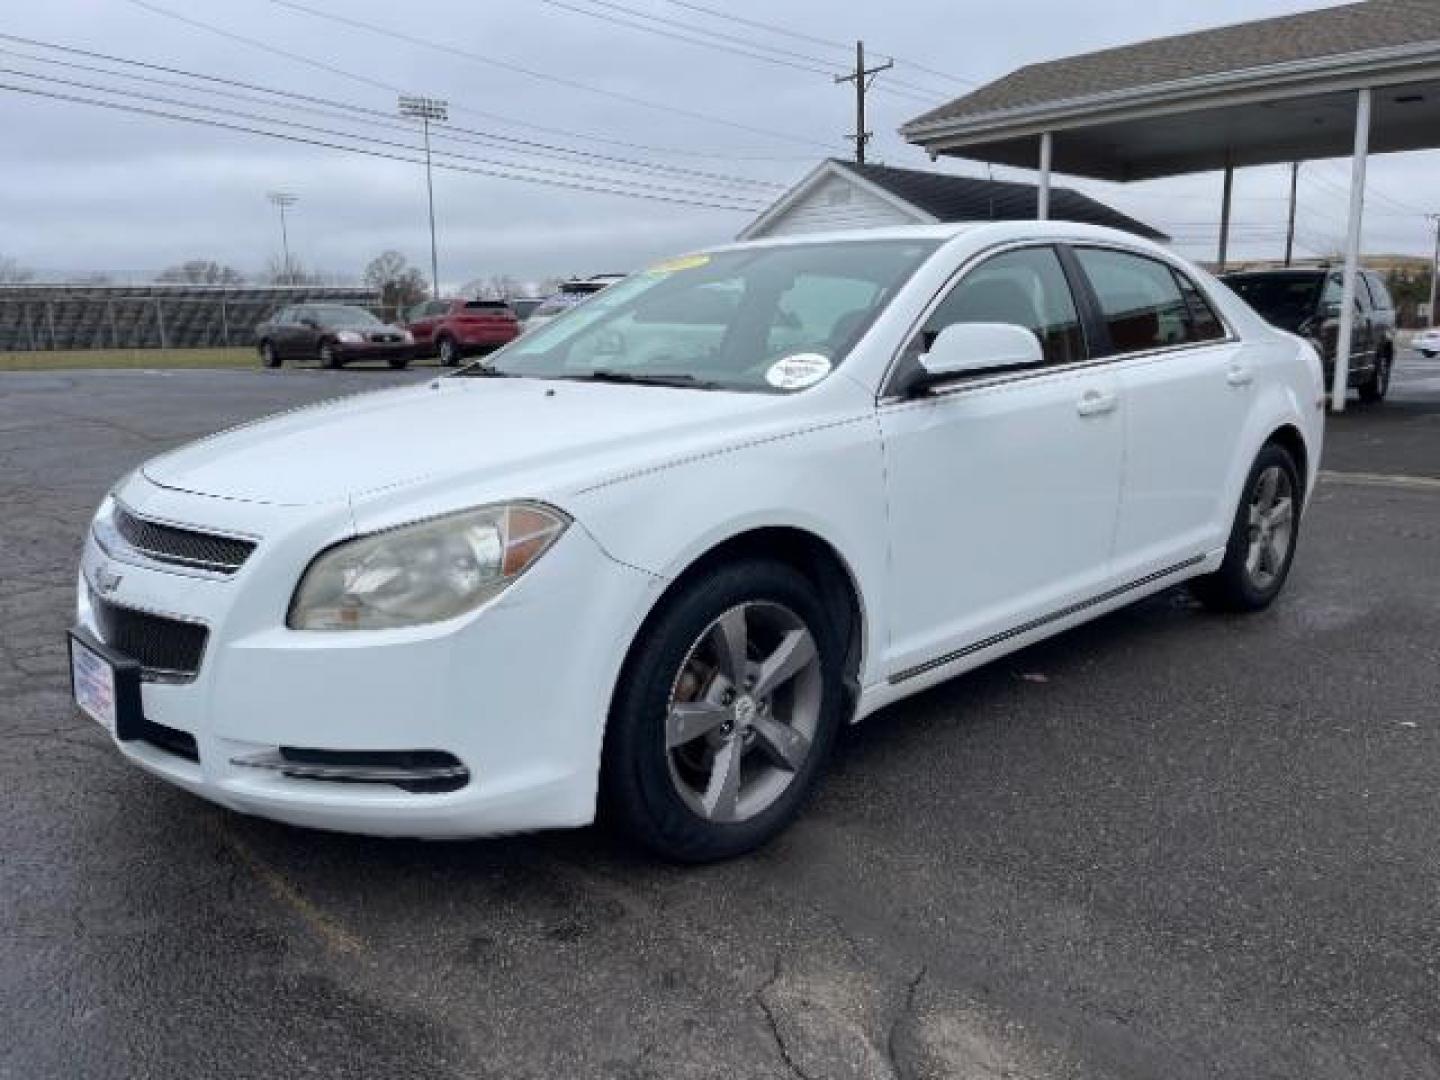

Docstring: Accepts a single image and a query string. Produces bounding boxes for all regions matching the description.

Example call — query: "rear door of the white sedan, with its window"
[1071,246,1256,585]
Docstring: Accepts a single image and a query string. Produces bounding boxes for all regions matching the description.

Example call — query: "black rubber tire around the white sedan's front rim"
[600,559,844,863]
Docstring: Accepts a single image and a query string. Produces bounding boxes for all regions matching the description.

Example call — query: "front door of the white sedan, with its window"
[880,246,1123,680]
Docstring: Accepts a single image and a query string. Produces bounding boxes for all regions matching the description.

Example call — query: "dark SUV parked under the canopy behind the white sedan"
[1221,266,1395,402]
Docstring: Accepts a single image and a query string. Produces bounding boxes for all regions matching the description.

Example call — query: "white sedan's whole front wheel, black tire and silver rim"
[602,560,842,863]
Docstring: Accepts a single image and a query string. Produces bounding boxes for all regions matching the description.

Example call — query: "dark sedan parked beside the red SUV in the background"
[255,304,415,367]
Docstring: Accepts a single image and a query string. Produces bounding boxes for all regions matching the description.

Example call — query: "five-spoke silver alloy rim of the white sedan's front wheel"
[665,602,822,824]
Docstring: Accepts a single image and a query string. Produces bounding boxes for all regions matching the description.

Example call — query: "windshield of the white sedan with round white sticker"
[488,240,939,392]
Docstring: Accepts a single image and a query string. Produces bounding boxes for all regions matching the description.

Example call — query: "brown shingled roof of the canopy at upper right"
[903,0,1440,134]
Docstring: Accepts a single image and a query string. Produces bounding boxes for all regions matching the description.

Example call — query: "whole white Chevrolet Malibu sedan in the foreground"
[71,222,1323,861]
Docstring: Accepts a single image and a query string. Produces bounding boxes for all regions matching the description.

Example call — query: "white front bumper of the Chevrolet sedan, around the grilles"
[76,481,660,838]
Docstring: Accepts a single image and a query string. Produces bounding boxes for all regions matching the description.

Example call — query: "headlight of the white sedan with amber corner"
[288,503,570,631]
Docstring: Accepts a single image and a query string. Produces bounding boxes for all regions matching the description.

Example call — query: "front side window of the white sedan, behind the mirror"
[922,248,1086,364]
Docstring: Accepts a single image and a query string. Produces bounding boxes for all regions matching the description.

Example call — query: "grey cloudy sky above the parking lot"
[0,0,1440,284]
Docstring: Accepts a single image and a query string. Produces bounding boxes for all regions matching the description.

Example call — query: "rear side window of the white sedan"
[1076,248,1223,353]
